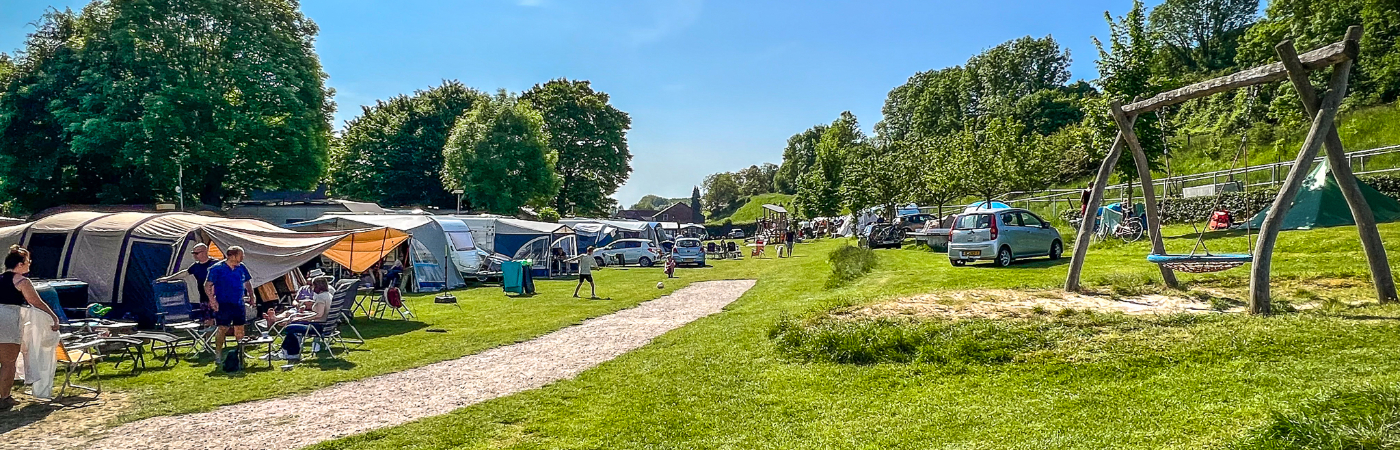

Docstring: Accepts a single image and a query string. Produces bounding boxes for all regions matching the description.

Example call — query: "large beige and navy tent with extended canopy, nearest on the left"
[0,212,406,325]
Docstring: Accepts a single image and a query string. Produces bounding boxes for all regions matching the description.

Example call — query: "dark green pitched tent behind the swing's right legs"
[1249,161,1400,230]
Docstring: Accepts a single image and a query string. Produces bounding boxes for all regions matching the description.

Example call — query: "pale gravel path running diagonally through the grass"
[71,280,755,450]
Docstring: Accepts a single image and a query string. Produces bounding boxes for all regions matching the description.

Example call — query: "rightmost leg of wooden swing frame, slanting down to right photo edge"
[1274,27,1397,303]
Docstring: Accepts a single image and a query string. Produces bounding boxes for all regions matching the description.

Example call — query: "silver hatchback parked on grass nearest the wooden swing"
[948,207,1064,266]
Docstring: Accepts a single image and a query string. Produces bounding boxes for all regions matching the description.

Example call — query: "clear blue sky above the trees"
[0,0,1158,206]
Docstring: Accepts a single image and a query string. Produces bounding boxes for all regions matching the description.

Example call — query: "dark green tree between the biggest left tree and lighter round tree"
[328,80,486,207]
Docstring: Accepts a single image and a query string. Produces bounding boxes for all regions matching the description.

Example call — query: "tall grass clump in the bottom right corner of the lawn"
[1231,387,1400,450]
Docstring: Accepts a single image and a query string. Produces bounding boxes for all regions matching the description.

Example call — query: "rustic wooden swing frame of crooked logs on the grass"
[1064,25,1397,314]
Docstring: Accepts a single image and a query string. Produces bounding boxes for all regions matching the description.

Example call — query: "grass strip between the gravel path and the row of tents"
[80,259,767,421]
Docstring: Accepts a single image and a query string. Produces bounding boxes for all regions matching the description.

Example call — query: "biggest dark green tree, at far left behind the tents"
[0,0,333,210]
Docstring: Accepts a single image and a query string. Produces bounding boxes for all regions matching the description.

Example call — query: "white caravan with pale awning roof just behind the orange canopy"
[283,214,475,292]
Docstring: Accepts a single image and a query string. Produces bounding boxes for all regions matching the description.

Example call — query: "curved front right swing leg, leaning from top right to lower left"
[1249,51,1351,314]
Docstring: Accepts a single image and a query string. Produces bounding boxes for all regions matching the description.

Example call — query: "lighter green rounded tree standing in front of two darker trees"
[442,90,559,214]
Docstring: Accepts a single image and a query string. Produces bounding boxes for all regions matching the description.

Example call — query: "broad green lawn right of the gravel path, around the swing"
[301,224,1400,449]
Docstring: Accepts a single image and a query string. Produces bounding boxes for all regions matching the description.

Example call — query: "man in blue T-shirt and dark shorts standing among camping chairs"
[204,245,253,353]
